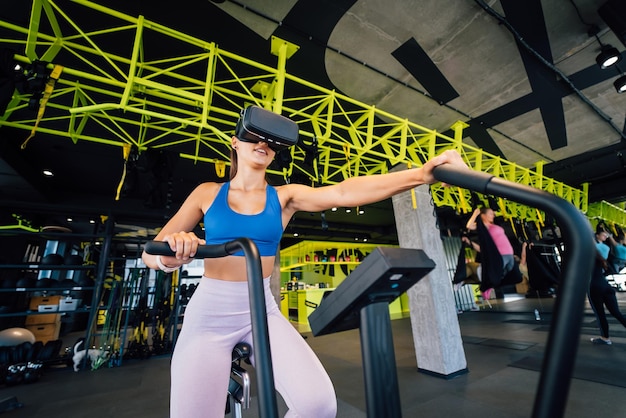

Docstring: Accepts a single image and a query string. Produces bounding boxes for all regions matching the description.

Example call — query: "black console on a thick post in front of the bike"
[309,247,435,418]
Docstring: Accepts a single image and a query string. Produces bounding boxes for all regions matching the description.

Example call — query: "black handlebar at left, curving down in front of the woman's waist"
[144,238,278,418]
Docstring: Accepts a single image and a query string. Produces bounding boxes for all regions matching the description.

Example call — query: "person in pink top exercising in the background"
[463,207,516,301]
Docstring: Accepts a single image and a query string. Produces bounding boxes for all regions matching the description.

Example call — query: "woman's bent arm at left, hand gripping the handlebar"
[141,183,217,269]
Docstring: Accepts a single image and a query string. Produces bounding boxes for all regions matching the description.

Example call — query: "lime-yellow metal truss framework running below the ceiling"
[0,0,620,227]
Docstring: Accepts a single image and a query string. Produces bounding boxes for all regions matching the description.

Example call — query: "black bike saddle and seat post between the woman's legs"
[226,342,252,418]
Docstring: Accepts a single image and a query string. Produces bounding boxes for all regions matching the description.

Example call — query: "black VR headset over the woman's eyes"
[235,106,299,152]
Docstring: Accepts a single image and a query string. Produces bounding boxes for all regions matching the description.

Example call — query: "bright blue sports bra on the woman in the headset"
[204,182,283,256]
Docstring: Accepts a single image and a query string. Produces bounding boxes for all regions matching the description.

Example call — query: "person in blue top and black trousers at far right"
[588,226,626,345]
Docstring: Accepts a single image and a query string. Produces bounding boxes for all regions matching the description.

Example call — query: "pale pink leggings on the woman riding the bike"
[170,277,337,418]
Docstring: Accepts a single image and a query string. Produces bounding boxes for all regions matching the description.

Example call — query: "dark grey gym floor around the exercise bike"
[0,293,626,418]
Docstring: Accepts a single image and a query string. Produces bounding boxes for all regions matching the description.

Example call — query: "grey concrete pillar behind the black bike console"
[392,181,467,378]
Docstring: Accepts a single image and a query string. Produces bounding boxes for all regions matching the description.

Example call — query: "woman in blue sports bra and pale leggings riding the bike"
[143,105,465,418]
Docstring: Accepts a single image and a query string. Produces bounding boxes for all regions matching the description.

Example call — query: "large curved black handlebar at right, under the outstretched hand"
[433,165,595,418]
